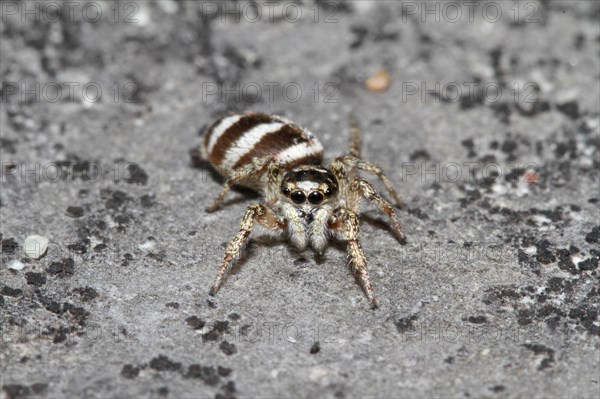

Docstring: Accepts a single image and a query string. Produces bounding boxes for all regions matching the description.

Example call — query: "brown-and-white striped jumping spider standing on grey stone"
[200,113,405,308]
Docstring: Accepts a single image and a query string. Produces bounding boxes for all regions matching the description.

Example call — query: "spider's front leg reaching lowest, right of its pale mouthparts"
[330,209,377,309]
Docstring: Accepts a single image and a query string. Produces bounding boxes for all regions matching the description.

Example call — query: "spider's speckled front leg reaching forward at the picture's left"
[210,204,285,295]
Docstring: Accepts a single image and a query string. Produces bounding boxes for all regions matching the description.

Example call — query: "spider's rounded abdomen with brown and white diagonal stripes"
[202,113,323,180]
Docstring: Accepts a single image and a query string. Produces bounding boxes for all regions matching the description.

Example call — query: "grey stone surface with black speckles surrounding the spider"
[0,1,600,398]
